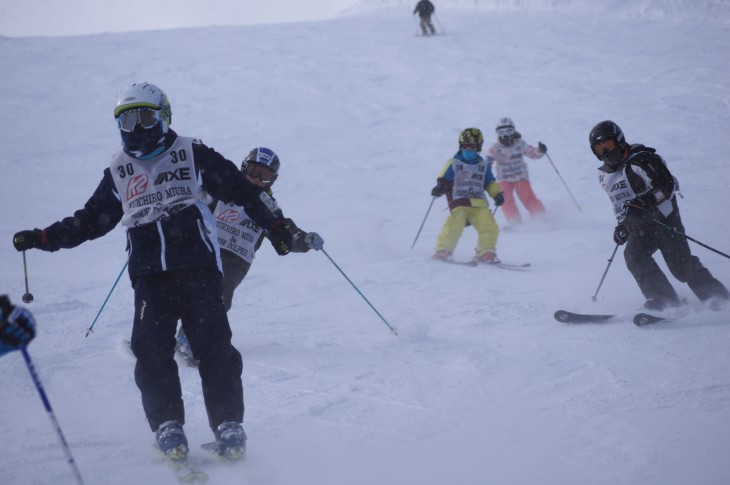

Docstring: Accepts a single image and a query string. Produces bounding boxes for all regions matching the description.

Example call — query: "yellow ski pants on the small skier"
[436,206,499,256]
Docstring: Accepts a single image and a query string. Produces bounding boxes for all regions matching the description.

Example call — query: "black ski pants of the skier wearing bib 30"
[132,268,243,431]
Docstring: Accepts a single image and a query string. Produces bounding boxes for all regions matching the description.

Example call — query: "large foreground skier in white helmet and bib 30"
[13,83,304,460]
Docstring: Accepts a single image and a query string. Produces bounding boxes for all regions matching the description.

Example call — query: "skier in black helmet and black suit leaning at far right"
[589,120,730,310]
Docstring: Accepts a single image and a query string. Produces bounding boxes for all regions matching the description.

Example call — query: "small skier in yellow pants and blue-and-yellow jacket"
[431,128,504,264]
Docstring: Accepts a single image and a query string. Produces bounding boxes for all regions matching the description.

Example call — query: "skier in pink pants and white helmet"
[485,118,547,224]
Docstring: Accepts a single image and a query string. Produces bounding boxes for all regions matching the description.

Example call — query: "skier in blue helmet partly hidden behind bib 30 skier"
[176,147,324,363]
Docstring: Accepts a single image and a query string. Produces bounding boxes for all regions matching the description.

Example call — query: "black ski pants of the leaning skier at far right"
[624,209,730,304]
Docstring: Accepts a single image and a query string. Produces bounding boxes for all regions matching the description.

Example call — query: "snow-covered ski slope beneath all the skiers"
[0,0,730,485]
